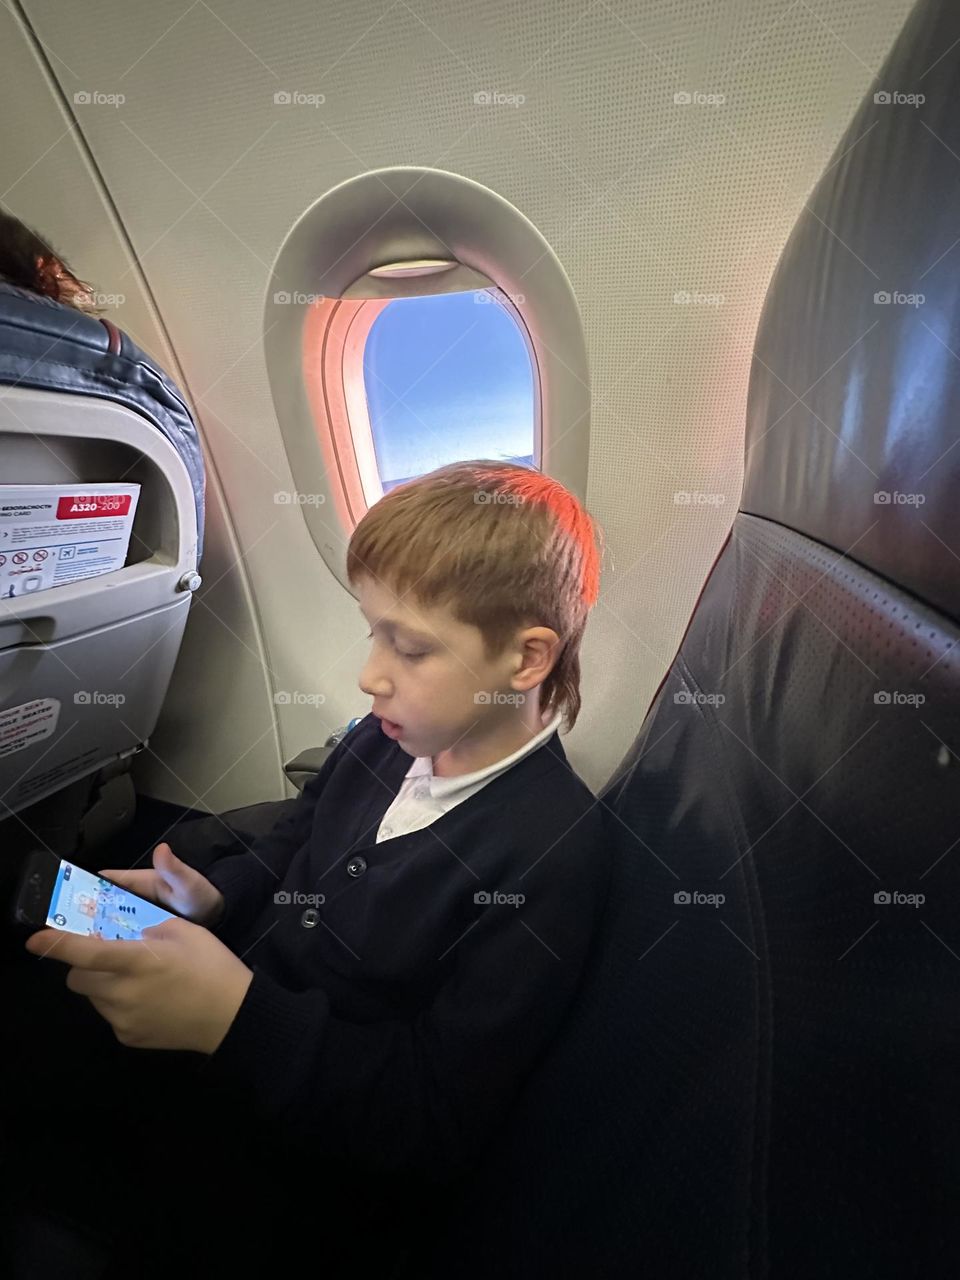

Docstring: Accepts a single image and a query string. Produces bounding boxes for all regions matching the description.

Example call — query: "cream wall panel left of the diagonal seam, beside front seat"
[0,5,283,812]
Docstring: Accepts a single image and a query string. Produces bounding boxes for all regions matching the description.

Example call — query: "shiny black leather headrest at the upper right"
[741,0,960,620]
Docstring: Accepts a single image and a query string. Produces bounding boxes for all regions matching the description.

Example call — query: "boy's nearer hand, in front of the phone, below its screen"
[27,920,253,1053]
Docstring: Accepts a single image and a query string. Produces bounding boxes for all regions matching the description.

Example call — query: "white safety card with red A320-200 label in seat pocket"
[0,484,140,599]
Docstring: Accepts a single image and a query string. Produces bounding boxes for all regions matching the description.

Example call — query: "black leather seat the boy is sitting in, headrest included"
[407,0,960,1280]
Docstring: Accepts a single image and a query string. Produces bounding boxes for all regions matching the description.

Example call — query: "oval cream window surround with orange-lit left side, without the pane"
[264,165,590,594]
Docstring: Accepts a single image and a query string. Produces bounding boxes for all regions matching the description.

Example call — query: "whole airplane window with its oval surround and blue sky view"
[264,165,590,590]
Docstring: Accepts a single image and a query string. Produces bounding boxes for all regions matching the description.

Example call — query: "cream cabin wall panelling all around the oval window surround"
[0,0,911,810]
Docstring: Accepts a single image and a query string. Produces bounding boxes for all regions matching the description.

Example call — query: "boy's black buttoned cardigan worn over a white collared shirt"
[205,714,608,1181]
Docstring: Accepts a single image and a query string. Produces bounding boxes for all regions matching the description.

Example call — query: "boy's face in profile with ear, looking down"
[357,576,557,756]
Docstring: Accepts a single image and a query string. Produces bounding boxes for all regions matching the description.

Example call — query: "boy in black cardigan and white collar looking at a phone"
[16,461,608,1275]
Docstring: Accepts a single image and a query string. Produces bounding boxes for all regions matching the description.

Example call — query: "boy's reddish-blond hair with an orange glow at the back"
[347,458,603,730]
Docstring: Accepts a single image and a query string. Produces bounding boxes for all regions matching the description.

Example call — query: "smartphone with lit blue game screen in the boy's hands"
[14,849,175,942]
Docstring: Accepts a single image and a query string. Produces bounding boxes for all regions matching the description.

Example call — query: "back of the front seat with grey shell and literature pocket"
[0,284,204,850]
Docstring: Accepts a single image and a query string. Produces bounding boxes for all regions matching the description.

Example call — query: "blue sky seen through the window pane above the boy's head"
[364,291,534,493]
